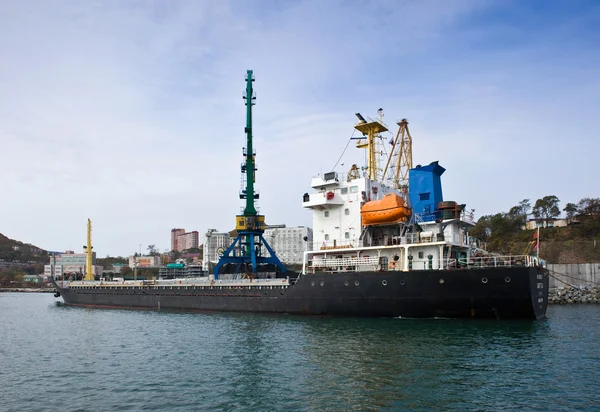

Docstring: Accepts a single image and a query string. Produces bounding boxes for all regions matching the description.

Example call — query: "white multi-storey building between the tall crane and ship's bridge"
[263,225,313,265]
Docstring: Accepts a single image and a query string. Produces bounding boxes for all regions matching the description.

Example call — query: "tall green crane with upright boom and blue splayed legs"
[213,70,286,279]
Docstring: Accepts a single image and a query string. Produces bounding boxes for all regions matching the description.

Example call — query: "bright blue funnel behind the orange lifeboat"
[408,161,446,222]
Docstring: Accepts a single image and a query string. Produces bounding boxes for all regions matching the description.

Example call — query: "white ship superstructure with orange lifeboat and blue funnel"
[302,115,526,273]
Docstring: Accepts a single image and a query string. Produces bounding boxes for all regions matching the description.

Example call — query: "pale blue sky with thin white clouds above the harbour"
[0,0,600,256]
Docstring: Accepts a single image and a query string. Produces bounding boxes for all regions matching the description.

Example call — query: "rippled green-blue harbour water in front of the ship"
[0,293,600,411]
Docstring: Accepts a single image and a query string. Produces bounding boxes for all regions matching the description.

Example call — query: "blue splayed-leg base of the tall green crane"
[213,231,286,279]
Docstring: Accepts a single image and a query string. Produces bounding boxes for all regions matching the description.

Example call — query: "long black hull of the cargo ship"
[52,267,548,319]
